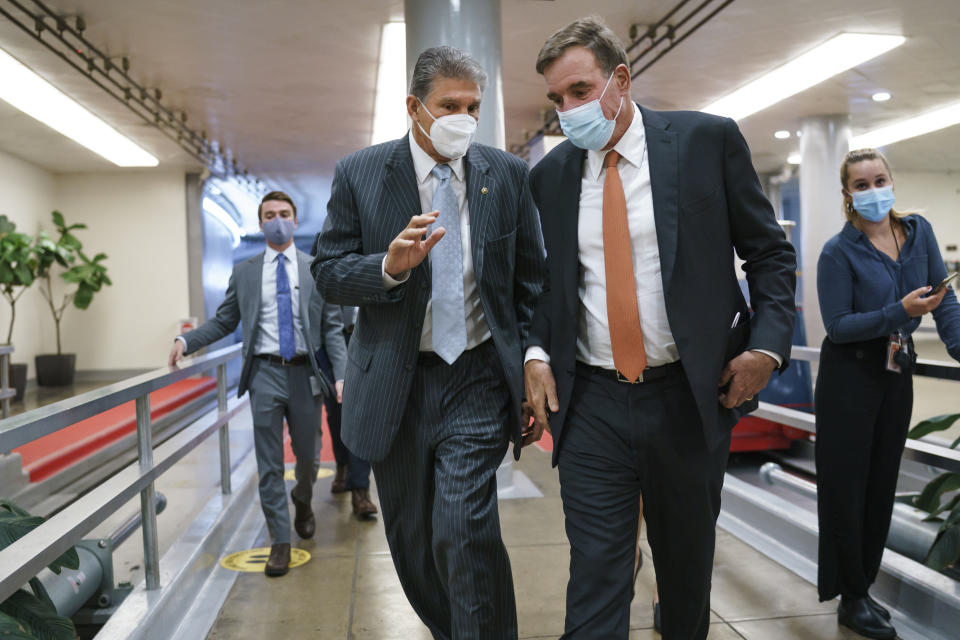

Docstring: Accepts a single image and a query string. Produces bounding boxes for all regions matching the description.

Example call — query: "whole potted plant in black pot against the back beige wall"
[34,211,112,386]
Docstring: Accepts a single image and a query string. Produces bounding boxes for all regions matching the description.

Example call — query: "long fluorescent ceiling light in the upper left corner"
[0,49,159,167]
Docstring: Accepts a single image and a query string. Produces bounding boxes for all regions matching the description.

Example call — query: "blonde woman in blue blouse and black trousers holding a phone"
[815,149,960,638]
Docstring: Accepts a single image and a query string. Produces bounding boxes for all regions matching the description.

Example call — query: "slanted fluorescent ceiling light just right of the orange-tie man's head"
[703,33,906,120]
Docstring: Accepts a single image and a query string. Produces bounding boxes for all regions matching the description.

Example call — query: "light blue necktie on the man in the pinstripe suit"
[430,164,467,364]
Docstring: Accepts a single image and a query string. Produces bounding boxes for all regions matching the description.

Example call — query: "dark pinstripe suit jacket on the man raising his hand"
[312,136,545,461]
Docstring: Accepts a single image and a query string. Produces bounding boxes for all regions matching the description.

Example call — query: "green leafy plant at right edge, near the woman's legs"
[908,413,960,571]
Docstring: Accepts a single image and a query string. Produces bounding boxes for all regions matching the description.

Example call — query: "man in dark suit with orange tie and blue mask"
[524,19,796,640]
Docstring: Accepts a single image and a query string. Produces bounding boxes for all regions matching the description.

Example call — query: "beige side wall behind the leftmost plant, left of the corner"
[0,151,56,377]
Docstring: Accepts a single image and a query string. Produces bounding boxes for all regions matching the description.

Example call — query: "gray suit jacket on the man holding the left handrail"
[183,251,347,396]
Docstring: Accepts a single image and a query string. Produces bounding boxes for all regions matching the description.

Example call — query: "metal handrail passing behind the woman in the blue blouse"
[751,345,960,473]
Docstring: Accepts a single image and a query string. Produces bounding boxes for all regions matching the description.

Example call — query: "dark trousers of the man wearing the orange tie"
[559,365,729,640]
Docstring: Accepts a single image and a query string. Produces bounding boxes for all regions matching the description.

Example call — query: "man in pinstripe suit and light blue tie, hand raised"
[313,47,544,640]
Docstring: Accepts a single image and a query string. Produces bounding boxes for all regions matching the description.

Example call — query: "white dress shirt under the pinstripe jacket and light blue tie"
[381,131,490,351]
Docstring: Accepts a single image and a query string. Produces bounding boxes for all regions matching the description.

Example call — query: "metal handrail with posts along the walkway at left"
[0,345,249,602]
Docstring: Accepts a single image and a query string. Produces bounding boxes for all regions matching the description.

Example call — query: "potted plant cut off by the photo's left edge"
[0,215,37,400]
